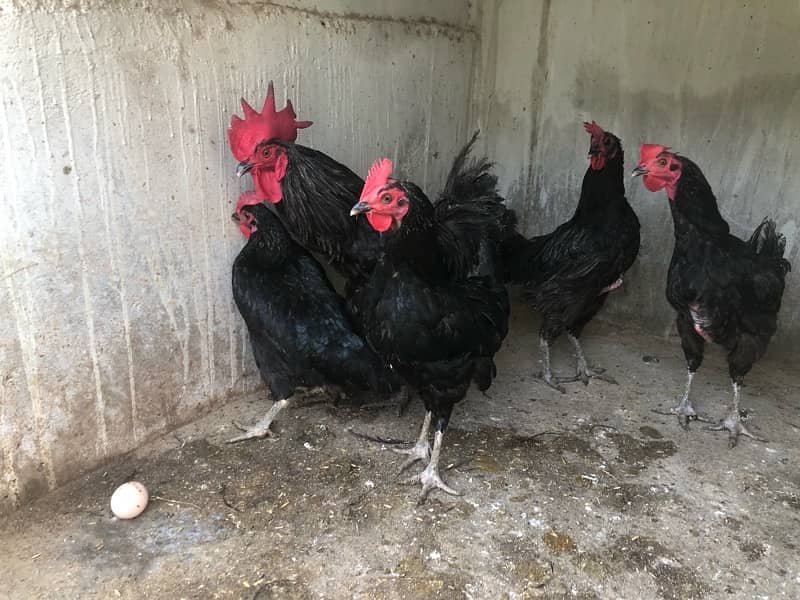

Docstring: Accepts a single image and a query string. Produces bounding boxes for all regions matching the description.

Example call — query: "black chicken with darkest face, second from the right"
[503,122,639,393]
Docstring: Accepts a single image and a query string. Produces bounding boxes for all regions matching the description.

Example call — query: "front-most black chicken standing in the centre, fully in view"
[350,134,516,502]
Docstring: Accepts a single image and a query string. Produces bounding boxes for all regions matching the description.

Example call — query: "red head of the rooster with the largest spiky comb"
[228,81,311,204]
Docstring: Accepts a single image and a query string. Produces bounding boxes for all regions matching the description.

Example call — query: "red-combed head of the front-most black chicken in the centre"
[350,158,409,233]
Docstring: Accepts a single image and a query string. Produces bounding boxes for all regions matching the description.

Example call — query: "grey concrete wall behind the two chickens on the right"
[473,0,800,344]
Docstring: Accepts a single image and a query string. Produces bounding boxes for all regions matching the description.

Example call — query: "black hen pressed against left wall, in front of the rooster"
[230,192,397,442]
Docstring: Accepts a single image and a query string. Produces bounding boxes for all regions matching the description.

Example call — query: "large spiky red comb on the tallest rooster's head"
[228,81,312,161]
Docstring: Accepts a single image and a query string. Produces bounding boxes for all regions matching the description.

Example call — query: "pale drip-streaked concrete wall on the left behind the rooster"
[0,0,477,508]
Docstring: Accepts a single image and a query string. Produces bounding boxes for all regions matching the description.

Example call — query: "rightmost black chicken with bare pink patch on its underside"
[633,144,791,447]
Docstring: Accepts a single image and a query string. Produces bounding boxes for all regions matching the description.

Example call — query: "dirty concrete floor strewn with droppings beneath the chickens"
[0,311,800,600]
